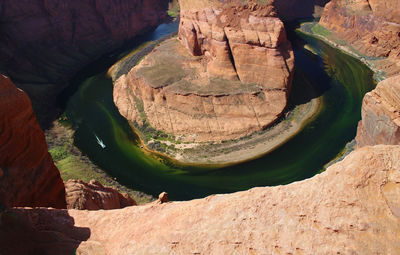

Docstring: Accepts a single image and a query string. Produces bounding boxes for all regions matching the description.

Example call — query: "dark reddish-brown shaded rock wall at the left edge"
[0,75,66,208]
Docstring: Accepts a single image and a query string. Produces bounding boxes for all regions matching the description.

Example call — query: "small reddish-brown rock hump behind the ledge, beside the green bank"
[65,180,136,210]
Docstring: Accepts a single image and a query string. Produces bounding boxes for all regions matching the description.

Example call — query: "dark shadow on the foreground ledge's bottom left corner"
[0,208,90,255]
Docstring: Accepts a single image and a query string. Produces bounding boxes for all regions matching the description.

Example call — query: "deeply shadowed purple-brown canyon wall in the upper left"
[0,0,168,124]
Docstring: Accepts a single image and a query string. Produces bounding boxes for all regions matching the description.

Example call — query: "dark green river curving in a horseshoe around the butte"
[65,24,375,200]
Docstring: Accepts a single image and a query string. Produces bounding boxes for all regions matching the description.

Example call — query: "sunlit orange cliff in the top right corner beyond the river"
[320,0,400,77]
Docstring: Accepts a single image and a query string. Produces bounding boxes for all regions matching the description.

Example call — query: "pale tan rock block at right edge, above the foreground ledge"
[356,75,400,147]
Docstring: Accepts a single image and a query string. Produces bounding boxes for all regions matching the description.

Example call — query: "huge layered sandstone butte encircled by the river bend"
[114,1,294,142]
